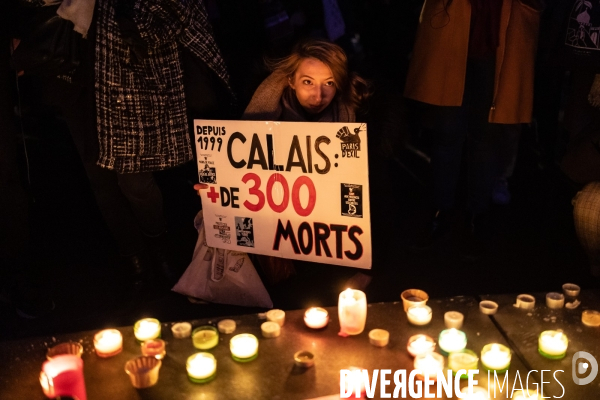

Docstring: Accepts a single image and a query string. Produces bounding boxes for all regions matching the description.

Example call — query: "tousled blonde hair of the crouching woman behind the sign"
[267,39,370,110]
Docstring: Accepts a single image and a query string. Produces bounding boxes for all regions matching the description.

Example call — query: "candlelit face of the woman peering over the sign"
[290,58,336,114]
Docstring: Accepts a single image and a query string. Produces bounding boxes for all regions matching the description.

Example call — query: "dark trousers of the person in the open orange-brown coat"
[431,60,502,214]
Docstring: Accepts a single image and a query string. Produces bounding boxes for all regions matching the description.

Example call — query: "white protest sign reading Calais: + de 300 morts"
[194,120,372,269]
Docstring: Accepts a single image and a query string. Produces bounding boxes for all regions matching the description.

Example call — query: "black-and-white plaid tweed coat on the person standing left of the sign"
[95,0,229,173]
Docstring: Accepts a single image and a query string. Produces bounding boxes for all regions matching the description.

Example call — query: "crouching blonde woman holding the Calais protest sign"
[194,39,371,289]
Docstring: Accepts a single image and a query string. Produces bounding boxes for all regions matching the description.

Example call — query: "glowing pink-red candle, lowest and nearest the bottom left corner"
[40,354,87,400]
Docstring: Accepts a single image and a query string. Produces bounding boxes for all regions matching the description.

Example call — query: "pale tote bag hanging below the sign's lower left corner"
[172,211,273,308]
